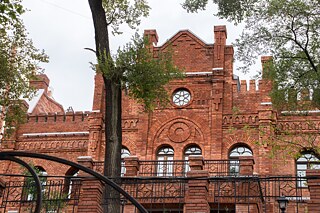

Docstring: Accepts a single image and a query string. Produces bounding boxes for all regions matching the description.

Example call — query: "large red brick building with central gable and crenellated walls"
[0,26,320,213]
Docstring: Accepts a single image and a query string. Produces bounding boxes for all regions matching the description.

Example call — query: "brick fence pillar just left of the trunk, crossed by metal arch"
[77,156,103,213]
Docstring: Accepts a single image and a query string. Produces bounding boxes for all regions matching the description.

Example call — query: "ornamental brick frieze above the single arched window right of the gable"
[222,114,259,126]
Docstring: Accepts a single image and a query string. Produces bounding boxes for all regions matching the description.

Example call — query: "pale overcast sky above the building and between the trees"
[23,0,251,111]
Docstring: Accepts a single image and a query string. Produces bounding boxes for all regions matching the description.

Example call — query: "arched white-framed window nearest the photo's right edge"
[296,152,320,187]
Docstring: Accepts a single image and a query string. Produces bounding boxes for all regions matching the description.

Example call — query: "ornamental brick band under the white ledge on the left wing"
[17,140,88,152]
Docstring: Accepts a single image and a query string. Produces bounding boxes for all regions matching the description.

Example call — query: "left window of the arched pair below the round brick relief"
[157,147,174,176]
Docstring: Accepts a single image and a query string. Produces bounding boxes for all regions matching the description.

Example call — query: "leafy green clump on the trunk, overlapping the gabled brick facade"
[99,34,183,111]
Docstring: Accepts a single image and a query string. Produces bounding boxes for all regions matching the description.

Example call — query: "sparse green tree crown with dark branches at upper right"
[235,0,320,110]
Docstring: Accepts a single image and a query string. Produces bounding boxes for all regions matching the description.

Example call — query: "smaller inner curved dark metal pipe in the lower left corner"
[0,155,42,213]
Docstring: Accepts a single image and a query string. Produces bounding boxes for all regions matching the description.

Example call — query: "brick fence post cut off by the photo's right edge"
[307,169,320,212]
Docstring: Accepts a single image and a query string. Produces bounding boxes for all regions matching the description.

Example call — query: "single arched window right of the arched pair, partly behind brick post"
[229,145,253,175]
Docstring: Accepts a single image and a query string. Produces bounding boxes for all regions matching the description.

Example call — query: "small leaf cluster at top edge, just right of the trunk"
[102,0,150,34]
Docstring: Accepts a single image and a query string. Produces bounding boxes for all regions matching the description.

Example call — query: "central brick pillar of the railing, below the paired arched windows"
[183,170,210,213]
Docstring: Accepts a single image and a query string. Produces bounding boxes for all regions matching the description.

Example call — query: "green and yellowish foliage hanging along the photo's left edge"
[0,0,48,138]
